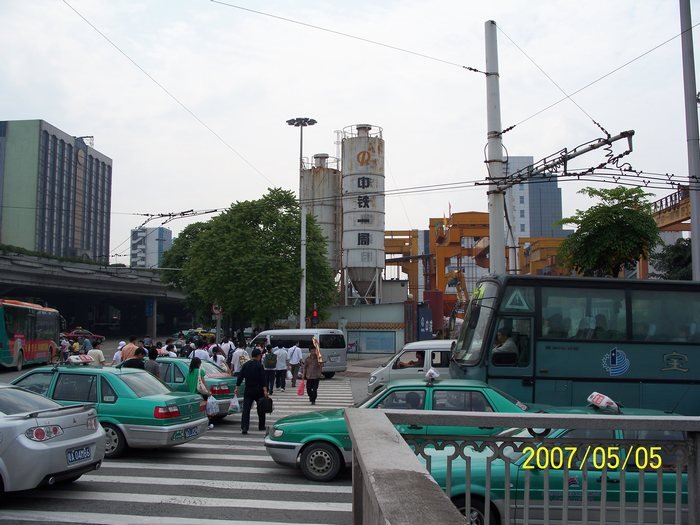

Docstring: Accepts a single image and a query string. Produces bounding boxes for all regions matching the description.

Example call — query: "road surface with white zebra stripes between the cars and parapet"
[0,377,353,525]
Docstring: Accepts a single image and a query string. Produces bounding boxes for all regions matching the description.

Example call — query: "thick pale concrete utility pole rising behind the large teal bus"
[485,20,506,274]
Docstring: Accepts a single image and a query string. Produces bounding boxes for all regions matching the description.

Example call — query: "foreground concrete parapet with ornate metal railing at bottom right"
[346,409,700,525]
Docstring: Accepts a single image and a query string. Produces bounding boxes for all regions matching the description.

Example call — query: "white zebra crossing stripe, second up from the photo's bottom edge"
[30,490,352,512]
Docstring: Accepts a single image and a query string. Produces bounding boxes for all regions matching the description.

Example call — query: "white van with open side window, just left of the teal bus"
[367,339,454,394]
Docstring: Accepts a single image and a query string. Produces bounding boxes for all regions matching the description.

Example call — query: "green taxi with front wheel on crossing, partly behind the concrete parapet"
[265,379,528,481]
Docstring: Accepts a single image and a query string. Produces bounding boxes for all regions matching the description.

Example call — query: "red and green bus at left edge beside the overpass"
[0,299,60,370]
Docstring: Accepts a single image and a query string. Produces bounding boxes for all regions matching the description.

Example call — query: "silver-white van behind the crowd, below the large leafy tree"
[246,328,348,379]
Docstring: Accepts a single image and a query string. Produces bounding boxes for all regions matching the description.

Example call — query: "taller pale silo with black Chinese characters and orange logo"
[342,124,385,304]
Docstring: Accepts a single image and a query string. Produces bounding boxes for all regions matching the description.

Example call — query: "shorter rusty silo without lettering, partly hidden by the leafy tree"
[301,153,341,273]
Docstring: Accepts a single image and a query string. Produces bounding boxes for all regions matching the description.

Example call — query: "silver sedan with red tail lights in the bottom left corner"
[0,384,105,494]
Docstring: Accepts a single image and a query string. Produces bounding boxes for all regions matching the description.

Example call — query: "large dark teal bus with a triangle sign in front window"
[450,275,700,415]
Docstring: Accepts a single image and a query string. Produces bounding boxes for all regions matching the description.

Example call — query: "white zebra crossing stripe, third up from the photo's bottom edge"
[80,474,352,494]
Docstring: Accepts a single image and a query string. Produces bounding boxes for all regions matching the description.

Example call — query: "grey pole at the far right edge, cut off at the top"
[680,0,700,281]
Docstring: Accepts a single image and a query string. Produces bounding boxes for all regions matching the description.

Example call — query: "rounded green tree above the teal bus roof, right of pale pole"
[559,186,661,277]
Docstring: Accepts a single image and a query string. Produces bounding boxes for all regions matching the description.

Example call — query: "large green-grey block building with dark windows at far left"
[0,120,112,262]
